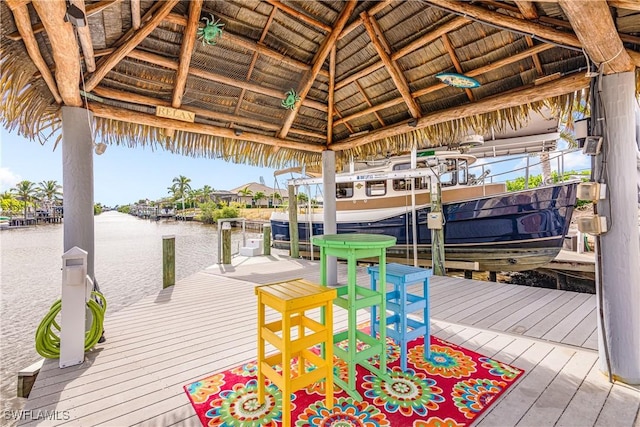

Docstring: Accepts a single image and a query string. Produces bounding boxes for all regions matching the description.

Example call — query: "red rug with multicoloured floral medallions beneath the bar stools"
[184,337,524,427]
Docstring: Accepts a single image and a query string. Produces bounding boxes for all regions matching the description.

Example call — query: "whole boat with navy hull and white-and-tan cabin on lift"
[270,151,579,271]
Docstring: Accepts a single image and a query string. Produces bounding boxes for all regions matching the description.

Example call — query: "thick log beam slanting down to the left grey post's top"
[31,0,82,107]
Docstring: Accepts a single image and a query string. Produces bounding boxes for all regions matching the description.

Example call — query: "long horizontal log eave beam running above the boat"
[329,73,591,151]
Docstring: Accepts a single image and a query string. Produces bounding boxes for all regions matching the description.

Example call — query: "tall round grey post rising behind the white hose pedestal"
[62,107,95,280]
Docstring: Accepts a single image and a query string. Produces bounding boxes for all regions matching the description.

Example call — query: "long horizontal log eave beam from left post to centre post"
[89,102,325,153]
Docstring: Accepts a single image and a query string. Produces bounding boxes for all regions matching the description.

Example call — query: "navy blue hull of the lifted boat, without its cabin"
[271,183,577,271]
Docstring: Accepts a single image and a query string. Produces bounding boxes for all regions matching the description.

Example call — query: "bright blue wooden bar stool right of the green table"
[367,263,432,371]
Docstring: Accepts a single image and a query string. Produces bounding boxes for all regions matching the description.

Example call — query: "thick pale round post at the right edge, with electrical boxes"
[592,72,640,384]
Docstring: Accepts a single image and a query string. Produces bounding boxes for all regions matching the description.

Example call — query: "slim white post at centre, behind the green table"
[322,150,338,285]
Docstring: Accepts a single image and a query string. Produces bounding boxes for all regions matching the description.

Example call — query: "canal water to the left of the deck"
[0,211,256,424]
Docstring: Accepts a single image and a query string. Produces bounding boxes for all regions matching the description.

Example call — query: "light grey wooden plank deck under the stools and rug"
[17,256,640,427]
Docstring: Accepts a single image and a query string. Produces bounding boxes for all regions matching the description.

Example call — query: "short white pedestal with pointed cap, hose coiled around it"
[58,246,87,368]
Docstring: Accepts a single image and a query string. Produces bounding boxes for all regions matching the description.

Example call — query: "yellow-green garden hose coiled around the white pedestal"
[36,291,107,359]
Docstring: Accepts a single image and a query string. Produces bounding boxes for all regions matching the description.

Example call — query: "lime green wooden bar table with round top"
[311,233,396,401]
